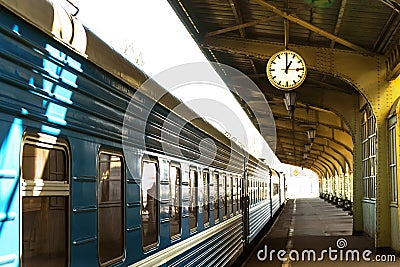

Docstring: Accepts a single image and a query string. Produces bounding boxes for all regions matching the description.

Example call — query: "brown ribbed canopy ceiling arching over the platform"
[169,0,400,177]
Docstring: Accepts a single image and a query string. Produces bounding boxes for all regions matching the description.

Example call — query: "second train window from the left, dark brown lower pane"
[97,151,125,265]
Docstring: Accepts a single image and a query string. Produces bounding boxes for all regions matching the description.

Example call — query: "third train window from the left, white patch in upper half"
[141,160,159,250]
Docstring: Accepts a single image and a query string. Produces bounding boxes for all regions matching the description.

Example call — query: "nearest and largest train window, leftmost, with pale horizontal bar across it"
[21,136,69,266]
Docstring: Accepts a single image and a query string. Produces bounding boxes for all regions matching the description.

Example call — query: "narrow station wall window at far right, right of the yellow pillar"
[389,116,398,203]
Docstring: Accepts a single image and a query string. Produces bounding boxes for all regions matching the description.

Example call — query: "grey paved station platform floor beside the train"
[242,198,400,267]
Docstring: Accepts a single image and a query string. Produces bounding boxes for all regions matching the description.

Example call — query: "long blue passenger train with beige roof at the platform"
[0,0,285,266]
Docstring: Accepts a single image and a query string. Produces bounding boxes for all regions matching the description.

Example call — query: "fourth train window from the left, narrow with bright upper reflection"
[169,165,181,239]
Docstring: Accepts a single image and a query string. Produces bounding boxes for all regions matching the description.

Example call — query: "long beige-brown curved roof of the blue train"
[0,0,269,172]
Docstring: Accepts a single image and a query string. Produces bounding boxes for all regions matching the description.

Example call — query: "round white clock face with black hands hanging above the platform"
[266,50,307,91]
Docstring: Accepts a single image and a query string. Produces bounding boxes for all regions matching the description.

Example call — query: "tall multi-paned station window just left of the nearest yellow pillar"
[361,106,376,199]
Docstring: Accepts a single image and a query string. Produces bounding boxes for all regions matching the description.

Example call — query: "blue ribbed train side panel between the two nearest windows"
[70,138,99,265]
